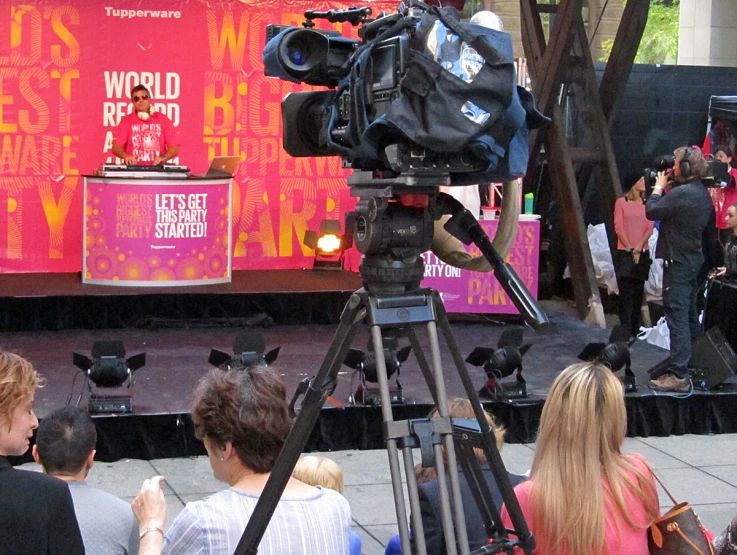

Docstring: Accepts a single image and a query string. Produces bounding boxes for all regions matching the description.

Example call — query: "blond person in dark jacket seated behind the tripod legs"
[412,398,525,555]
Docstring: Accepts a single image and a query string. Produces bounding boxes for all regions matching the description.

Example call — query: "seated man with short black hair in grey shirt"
[33,407,138,555]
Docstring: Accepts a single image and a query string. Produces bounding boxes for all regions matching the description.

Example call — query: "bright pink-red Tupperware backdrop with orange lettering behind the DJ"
[0,0,396,272]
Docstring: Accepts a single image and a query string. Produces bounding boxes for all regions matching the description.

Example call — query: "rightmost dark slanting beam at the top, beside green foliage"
[599,0,650,125]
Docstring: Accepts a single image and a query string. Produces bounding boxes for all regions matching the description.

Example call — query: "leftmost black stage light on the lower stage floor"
[72,341,146,413]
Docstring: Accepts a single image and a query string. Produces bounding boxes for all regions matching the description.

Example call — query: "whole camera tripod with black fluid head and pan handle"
[235,180,548,555]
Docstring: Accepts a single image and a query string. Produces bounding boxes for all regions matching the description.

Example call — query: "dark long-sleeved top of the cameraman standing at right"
[645,181,715,268]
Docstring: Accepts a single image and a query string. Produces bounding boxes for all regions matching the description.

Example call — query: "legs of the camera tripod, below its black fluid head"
[235,288,535,555]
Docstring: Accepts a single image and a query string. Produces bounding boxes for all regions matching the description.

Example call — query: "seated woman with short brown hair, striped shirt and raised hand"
[133,367,351,555]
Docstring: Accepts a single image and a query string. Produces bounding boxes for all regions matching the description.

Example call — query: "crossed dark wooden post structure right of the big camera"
[520,0,650,327]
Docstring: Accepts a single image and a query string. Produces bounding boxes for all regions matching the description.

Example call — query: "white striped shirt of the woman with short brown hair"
[162,488,351,555]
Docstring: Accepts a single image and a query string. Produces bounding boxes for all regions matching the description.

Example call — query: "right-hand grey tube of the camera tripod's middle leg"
[427,322,468,555]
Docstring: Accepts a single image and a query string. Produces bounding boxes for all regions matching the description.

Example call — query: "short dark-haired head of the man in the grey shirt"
[33,407,97,476]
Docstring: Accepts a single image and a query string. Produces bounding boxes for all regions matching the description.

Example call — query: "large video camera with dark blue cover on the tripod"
[263,2,546,185]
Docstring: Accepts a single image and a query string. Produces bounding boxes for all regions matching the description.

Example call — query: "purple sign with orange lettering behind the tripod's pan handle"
[422,220,540,314]
